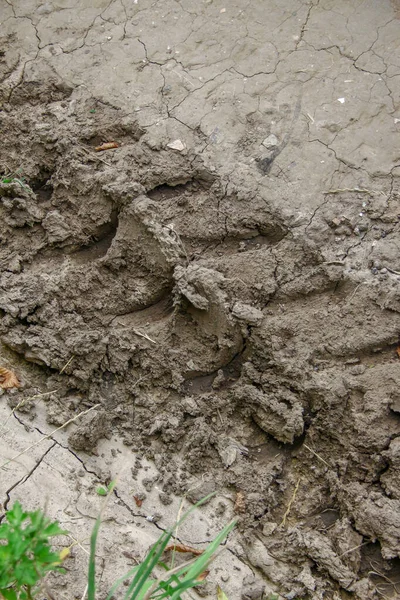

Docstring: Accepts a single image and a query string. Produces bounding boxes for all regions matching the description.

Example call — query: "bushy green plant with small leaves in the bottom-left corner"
[0,502,66,600]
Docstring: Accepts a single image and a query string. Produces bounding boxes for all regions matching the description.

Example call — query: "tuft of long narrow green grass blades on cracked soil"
[88,488,236,600]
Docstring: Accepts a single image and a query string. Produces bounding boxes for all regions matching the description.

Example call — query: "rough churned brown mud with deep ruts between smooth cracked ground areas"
[0,76,400,600]
